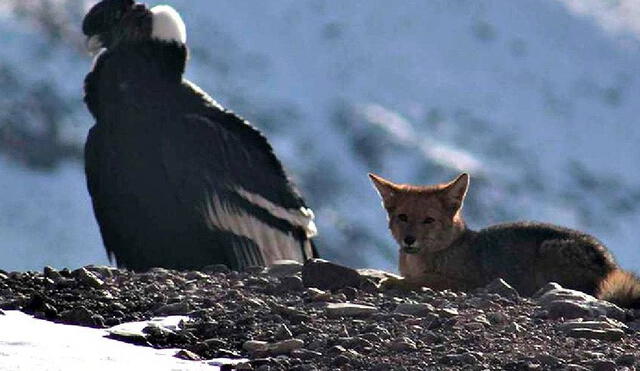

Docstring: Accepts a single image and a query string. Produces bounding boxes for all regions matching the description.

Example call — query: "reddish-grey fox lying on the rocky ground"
[369,173,640,308]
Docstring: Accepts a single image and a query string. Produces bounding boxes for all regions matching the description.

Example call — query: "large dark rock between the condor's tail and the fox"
[302,259,360,290]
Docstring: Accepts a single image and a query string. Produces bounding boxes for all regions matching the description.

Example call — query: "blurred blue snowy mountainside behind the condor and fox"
[0,0,640,271]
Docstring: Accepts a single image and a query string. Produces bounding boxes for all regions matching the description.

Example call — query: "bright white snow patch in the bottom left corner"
[0,311,234,371]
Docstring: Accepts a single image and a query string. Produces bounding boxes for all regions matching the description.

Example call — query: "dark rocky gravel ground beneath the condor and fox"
[0,260,640,370]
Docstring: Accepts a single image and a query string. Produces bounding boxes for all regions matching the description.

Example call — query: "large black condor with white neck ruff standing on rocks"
[82,0,317,270]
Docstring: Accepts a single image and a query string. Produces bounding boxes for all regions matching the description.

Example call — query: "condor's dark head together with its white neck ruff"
[82,0,187,54]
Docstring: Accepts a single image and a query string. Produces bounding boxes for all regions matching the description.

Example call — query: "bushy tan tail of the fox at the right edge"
[596,269,640,309]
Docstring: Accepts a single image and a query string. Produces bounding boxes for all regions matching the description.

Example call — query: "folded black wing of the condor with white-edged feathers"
[161,107,315,266]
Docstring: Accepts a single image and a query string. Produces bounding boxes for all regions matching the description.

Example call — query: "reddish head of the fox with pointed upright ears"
[369,173,469,254]
